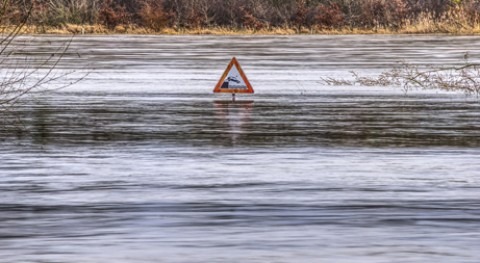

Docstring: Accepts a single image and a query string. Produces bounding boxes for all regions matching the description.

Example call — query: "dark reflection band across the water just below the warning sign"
[3,93,480,147]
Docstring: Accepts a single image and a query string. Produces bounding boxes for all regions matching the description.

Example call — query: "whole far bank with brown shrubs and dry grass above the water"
[1,0,480,34]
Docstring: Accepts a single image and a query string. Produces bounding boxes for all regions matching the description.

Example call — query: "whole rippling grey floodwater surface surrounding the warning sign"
[0,35,480,263]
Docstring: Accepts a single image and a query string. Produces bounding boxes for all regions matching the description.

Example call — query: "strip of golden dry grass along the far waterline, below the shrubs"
[8,10,480,35]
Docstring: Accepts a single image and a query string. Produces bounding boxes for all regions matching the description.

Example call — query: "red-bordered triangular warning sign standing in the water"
[213,57,253,93]
